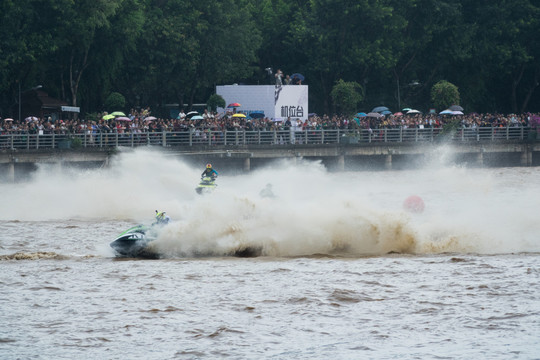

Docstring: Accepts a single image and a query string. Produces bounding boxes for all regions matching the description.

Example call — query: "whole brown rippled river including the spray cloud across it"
[0,150,540,359]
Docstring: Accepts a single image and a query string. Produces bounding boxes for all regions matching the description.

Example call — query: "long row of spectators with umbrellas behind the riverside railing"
[0,108,538,135]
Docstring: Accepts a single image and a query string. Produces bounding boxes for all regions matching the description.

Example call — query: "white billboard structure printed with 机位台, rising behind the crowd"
[216,85,308,120]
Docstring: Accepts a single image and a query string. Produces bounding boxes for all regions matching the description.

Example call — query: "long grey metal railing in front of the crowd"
[0,127,536,150]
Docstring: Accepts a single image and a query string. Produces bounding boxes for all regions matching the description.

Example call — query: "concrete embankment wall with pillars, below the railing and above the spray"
[0,141,540,182]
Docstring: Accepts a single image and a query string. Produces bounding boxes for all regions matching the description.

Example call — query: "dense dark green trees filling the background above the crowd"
[0,0,540,117]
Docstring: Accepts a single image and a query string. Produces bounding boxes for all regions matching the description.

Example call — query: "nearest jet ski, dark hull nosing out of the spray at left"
[110,225,159,259]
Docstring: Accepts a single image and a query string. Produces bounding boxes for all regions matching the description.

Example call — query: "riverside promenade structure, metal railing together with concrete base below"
[0,127,540,182]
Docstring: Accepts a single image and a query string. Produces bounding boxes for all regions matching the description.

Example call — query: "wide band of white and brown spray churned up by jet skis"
[0,149,540,257]
